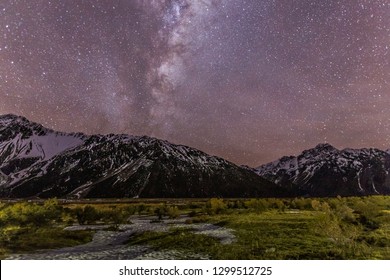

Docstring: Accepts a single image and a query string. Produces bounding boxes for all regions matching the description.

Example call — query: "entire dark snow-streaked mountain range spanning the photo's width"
[0,115,390,199]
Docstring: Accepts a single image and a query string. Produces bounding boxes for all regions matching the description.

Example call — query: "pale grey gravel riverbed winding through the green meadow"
[8,216,235,260]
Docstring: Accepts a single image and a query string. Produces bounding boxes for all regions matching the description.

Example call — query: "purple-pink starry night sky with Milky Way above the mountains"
[0,0,390,166]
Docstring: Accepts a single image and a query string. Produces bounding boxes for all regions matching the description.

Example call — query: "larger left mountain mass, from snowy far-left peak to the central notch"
[0,115,285,198]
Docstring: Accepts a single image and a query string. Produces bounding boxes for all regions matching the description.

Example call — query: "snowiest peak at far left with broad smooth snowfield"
[0,115,86,186]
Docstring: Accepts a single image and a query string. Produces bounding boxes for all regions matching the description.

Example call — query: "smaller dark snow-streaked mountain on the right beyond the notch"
[256,144,390,196]
